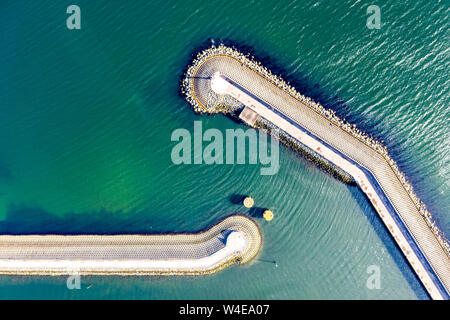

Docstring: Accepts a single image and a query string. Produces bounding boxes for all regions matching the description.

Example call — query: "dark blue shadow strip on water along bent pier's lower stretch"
[347,182,430,299]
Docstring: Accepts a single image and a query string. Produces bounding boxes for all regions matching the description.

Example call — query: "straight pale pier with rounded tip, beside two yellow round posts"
[0,215,262,275]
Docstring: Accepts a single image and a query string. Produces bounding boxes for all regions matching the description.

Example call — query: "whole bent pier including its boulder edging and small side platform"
[182,46,450,299]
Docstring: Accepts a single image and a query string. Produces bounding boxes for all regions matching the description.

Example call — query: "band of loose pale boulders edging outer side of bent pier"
[181,45,450,257]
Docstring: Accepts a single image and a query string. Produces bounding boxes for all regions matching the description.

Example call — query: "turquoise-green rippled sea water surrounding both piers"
[0,0,450,299]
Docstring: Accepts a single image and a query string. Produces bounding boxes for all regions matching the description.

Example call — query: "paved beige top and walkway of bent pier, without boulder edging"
[192,54,450,299]
